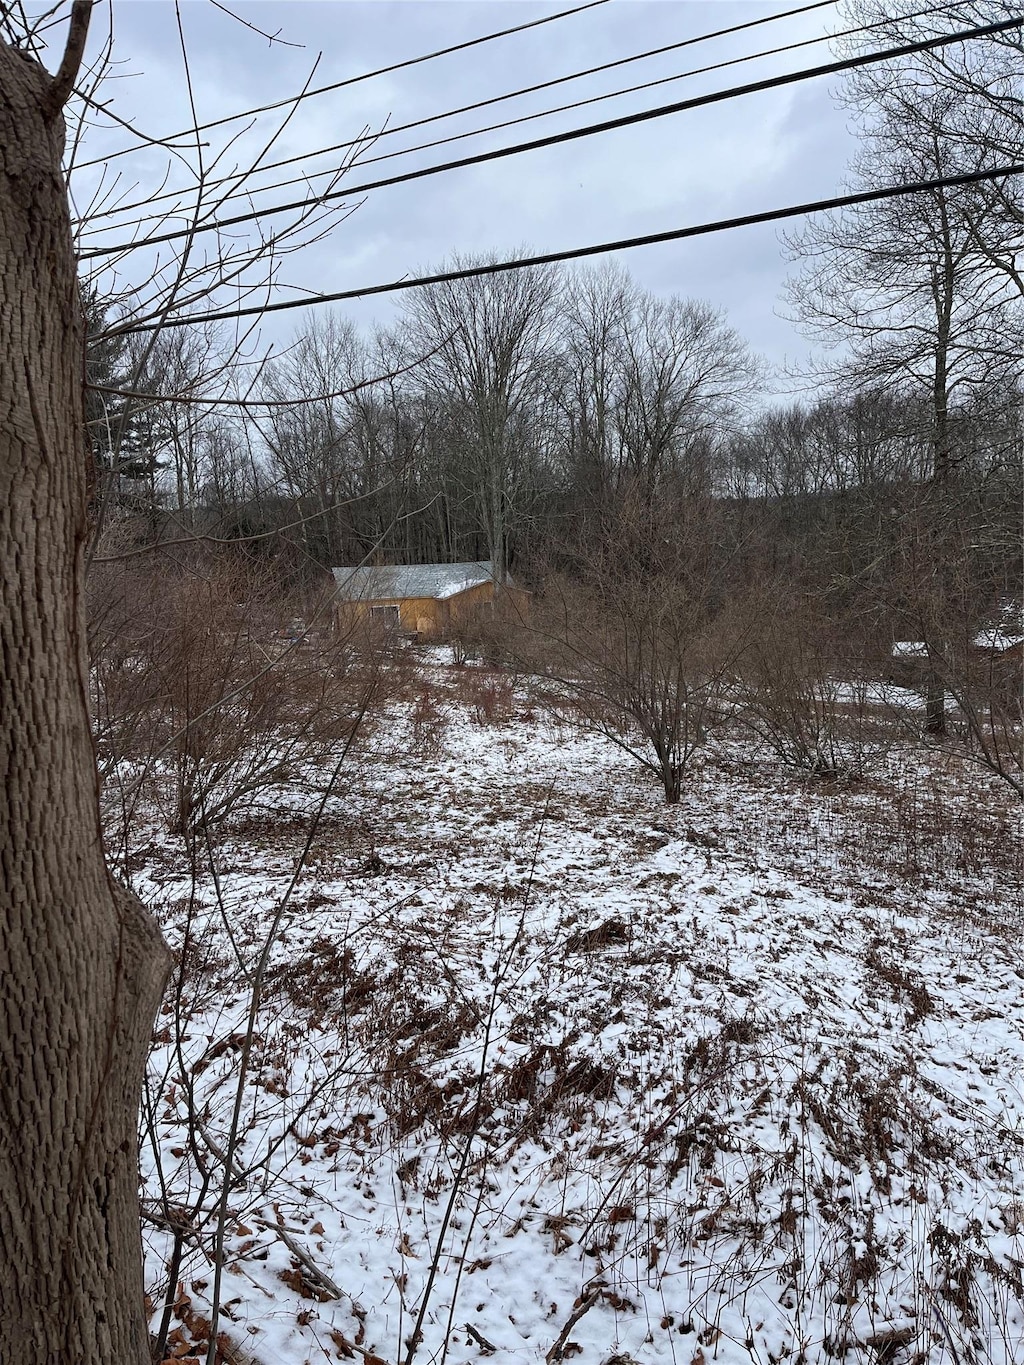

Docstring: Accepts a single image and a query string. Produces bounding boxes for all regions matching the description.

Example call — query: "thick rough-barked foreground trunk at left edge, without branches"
[0,26,168,1365]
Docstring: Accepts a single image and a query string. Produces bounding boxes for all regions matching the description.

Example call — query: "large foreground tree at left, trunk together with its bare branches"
[0,0,393,1348]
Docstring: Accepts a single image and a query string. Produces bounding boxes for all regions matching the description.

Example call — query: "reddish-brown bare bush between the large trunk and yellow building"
[91,551,393,835]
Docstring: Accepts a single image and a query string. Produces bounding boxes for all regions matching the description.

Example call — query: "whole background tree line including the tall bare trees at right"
[90,0,1024,728]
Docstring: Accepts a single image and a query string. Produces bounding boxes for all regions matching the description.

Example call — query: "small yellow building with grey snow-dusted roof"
[330,560,527,640]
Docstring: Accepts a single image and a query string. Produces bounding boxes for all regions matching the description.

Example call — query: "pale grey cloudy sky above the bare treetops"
[62,0,855,382]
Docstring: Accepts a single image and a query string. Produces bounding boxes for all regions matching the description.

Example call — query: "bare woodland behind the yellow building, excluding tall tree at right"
[91,248,1024,657]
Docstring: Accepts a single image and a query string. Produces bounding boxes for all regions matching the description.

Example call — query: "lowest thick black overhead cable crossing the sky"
[110,162,1024,337]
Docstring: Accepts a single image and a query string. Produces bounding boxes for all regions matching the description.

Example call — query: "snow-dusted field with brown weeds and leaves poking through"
[123,655,1024,1365]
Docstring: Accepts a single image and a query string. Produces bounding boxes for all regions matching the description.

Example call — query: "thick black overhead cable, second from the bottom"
[79,15,1024,261]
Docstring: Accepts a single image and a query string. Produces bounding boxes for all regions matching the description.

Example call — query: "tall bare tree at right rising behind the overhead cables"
[788,37,1023,733]
